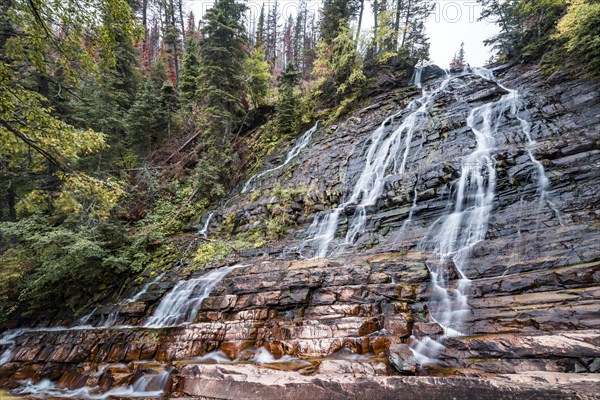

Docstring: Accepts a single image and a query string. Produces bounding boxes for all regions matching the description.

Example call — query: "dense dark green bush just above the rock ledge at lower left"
[0,215,131,310]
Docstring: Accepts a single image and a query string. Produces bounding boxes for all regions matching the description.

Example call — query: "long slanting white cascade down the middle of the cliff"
[301,74,451,258]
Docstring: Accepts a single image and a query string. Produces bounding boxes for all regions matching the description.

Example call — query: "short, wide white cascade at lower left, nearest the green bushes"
[144,264,246,328]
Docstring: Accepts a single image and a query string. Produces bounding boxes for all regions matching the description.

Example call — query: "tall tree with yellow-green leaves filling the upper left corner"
[0,0,136,223]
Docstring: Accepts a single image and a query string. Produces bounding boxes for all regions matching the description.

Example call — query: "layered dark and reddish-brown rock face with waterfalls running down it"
[0,68,600,399]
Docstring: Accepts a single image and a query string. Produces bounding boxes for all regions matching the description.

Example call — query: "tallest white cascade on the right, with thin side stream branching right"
[412,68,560,364]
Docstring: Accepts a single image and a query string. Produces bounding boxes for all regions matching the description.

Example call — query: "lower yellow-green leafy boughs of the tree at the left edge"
[0,64,122,223]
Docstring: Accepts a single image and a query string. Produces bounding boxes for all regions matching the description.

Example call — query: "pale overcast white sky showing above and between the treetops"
[184,0,498,68]
